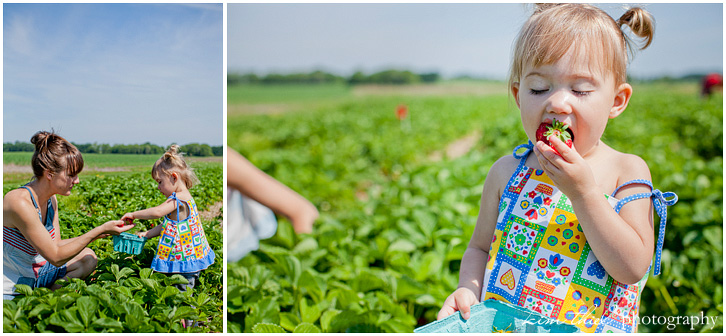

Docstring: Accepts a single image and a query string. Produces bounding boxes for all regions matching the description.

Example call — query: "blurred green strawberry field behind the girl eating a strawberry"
[227,84,723,332]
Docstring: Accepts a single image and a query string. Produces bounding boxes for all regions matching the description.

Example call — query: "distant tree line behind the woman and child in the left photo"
[3,141,224,156]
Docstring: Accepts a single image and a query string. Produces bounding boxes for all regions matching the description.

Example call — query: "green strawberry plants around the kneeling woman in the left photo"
[3,159,224,333]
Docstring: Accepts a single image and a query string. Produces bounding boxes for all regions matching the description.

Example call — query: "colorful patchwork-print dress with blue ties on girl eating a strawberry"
[481,143,677,332]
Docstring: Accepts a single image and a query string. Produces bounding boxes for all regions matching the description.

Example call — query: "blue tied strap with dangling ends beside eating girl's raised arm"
[611,179,678,275]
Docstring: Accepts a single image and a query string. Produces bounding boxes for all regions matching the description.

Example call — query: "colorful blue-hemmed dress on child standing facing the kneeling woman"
[151,193,215,273]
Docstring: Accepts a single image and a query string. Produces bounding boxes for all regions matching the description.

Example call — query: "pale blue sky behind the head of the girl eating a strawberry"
[227,3,723,79]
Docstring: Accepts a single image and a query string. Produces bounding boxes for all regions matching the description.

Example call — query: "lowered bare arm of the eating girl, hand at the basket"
[437,157,516,320]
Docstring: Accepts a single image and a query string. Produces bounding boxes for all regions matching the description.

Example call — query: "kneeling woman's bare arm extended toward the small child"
[3,196,133,267]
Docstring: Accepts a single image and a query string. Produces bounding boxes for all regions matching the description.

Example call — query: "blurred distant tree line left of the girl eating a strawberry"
[227,70,440,86]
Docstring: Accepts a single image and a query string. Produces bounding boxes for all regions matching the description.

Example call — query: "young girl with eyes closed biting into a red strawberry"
[438,4,677,332]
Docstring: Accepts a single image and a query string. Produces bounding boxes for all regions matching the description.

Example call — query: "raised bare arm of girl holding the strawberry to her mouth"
[535,137,654,284]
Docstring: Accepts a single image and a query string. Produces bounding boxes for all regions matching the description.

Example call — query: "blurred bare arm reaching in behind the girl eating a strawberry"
[227,148,319,233]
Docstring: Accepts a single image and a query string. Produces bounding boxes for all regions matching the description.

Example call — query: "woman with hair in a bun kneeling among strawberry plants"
[3,132,133,300]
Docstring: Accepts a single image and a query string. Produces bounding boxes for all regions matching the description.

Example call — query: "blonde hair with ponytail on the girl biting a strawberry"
[509,3,655,87]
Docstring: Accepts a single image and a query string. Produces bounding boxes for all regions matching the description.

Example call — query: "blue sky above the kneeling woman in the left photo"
[3,4,225,146]
